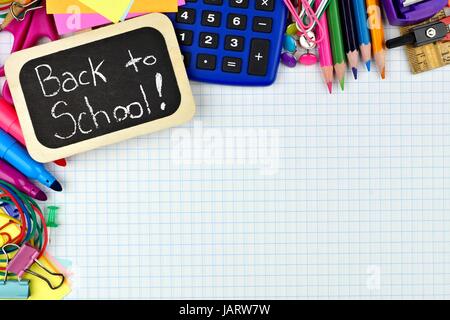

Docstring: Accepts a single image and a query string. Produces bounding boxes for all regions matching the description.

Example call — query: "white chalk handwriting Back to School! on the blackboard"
[34,50,166,140]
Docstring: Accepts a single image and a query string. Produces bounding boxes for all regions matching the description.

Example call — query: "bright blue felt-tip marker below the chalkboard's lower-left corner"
[0,129,62,191]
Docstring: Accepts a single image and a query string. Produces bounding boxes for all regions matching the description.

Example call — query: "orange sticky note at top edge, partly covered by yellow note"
[46,0,178,14]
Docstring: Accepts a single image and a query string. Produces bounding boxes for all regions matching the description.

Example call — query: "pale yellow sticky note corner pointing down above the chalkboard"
[79,0,133,23]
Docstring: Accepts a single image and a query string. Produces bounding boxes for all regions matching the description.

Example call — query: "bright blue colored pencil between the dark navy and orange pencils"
[353,0,372,71]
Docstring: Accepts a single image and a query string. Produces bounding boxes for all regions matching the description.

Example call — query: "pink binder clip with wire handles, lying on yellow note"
[2,243,65,290]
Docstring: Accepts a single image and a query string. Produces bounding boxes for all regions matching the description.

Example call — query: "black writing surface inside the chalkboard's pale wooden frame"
[20,27,181,148]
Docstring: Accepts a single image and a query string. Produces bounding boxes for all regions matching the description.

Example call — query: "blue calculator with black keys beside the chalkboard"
[171,0,287,86]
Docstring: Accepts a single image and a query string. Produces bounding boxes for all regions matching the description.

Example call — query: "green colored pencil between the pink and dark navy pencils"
[327,0,347,90]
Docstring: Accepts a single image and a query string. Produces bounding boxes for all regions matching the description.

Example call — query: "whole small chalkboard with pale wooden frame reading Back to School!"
[5,13,195,162]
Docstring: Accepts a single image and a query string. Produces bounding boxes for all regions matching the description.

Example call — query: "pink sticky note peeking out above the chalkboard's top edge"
[54,0,185,35]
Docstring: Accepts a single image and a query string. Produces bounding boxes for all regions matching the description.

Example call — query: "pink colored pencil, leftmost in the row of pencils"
[315,0,334,94]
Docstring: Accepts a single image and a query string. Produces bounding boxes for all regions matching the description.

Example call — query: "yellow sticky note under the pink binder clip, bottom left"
[23,253,71,300]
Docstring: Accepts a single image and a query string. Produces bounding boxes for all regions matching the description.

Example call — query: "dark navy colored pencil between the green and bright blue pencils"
[339,0,359,79]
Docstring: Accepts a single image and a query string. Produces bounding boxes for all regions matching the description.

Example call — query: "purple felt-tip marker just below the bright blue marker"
[0,160,47,201]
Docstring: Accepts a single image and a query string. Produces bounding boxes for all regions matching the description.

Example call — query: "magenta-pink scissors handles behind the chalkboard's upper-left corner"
[0,3,59,104]
